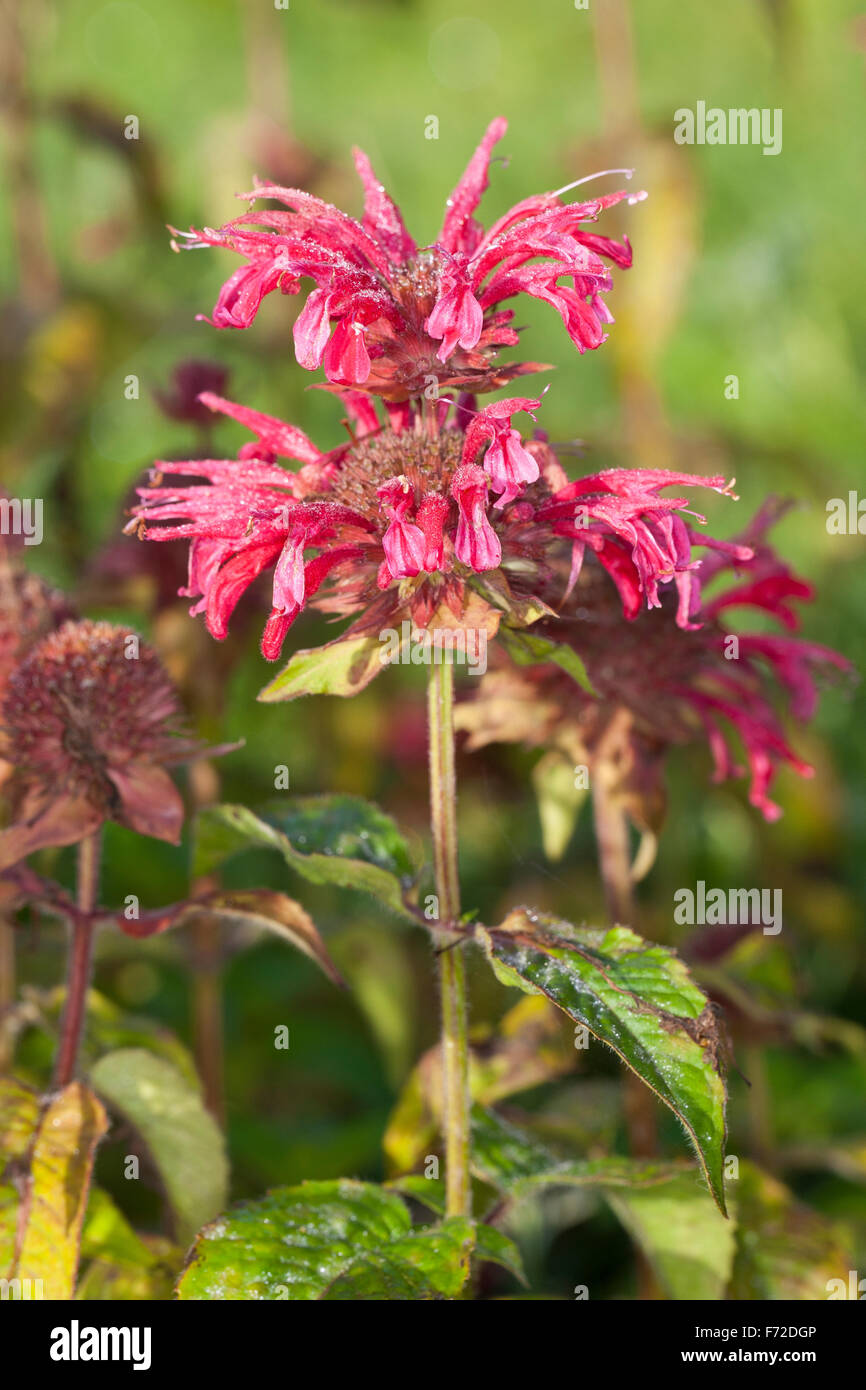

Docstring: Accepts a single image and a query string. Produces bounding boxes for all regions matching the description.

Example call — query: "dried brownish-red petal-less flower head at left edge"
[0,621,209,870]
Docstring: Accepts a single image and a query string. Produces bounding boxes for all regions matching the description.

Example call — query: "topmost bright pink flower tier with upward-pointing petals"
[177,118,644,402]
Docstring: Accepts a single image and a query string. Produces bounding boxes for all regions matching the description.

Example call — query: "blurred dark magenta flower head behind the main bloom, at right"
[457,503,851,828]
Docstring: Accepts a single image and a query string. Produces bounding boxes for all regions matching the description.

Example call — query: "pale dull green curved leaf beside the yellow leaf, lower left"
[90,1048,228,1241]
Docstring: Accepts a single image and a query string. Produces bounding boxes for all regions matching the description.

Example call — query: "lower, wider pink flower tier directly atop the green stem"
[128,391,751,678]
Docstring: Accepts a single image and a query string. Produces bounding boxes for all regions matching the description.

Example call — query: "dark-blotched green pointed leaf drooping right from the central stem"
[475,909,726,1212]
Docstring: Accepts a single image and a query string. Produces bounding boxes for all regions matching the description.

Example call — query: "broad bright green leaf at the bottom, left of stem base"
[178,1179,474,1301]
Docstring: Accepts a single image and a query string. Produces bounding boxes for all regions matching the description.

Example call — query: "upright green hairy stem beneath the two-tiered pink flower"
[427,663,471,1216]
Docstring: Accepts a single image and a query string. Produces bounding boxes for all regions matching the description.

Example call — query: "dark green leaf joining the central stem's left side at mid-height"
[193,796,416,922]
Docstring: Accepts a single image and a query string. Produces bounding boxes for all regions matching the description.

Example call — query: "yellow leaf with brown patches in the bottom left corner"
[14,1081,108,1300]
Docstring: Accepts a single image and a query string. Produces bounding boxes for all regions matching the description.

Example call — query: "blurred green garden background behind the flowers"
[0,0,866,1297]
